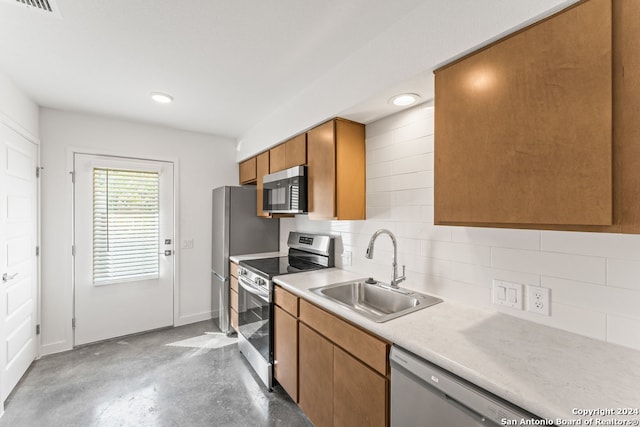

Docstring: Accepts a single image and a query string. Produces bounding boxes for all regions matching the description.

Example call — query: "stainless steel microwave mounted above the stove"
[262,166,307,214]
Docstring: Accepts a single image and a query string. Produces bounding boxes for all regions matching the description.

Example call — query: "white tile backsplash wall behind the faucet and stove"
[280,106,640,349]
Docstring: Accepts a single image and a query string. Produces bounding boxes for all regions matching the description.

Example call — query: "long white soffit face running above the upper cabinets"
[237,0,576,160]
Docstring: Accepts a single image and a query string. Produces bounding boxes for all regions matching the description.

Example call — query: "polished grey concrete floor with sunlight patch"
[0,321,311,427]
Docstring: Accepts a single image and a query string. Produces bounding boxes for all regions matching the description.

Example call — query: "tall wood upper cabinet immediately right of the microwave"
[307,118,366,220]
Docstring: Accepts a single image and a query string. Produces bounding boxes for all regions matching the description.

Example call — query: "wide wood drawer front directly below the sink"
[300,300,389,376]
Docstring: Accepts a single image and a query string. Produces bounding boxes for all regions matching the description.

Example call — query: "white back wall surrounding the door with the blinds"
[40,109,238,354]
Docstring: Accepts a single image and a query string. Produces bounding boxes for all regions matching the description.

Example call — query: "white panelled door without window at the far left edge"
[0,123,38,402]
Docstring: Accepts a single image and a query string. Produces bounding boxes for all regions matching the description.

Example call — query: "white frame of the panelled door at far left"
[0,111,44,362]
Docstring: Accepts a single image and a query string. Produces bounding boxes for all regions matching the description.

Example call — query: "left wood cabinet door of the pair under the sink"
[298,323,333,427]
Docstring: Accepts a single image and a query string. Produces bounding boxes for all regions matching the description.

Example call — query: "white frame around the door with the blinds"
[66,146,180,348]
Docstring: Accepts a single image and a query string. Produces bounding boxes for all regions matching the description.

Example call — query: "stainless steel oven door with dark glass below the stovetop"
[238,277,273,380]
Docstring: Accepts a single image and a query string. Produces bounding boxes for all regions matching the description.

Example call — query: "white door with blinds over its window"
[74,153,174,345]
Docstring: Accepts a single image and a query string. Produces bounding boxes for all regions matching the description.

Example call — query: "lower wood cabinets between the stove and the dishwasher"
[274,287,390,427]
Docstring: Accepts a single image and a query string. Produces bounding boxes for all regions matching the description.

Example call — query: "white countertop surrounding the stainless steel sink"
[274,268,640,425]
